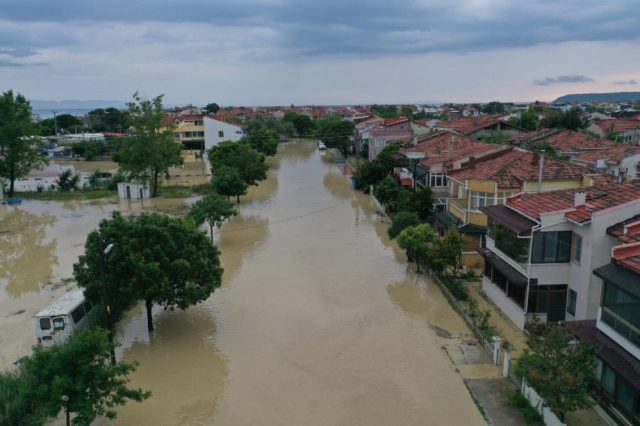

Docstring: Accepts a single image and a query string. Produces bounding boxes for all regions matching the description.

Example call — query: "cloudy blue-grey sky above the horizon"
[0,0,640,106]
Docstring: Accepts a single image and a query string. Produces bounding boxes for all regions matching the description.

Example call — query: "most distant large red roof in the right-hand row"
[436,115,526,140]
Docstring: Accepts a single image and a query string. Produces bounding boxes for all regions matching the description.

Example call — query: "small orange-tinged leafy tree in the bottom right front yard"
[515,324,596,421]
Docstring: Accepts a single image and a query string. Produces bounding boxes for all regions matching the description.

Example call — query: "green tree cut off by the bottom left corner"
[0,368,47,426]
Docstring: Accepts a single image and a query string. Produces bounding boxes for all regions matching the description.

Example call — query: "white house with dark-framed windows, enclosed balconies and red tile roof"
[480,182,640,328]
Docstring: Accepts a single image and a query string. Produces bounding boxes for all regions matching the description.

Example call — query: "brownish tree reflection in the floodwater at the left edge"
[0,207,58,298]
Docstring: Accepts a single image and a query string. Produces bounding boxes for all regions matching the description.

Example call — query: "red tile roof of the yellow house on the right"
[449,148,591,188]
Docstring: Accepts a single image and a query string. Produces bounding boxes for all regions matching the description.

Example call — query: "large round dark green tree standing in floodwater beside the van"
[74,213,222,331]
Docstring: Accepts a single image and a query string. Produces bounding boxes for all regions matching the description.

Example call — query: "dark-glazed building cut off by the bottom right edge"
[564,215,640,425]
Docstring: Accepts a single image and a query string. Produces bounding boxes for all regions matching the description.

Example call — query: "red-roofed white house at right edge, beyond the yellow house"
[572,144,640,182]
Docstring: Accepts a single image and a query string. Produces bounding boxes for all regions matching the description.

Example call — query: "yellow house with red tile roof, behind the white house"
[447,148,612,268]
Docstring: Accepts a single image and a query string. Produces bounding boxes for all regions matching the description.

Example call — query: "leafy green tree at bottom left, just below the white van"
[23,329,151,426]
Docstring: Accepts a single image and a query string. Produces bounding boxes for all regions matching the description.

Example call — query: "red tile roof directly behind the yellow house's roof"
[400,132,510,166]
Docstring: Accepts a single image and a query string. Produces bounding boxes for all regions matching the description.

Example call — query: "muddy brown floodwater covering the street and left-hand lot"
[0,142,486,426]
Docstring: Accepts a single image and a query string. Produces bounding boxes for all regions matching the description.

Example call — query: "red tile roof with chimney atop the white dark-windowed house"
[506,181,640,223]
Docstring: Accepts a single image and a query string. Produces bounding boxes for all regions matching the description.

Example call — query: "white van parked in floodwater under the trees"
[36,290,93,348]
